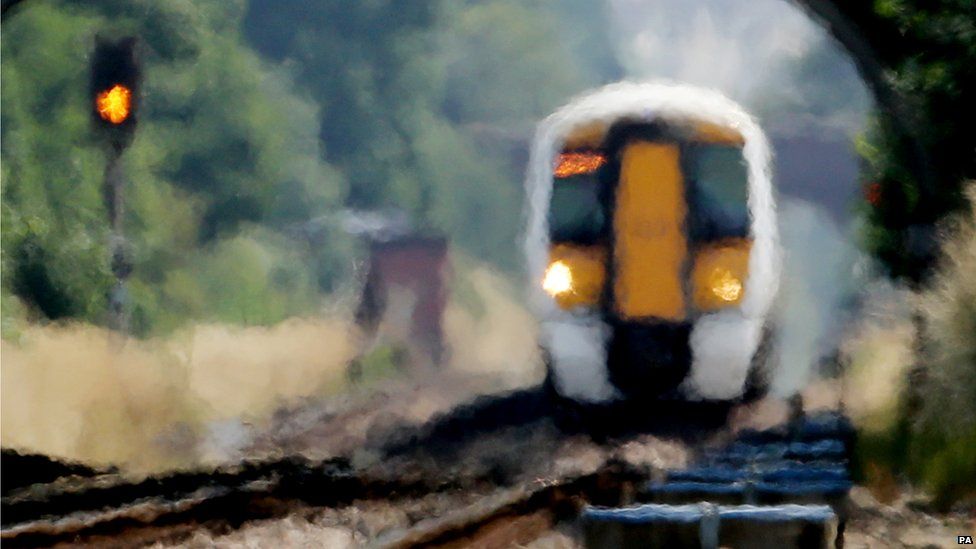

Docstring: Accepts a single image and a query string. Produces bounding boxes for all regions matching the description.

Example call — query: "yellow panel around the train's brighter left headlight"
[543,244,607,309]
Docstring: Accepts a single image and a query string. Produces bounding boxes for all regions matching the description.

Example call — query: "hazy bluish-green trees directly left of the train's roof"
[245,0,619,269]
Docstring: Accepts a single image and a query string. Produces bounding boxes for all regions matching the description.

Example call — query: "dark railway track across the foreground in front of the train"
[0,389,851,547]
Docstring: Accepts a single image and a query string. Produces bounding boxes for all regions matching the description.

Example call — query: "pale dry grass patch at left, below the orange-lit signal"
[0,319,354,471]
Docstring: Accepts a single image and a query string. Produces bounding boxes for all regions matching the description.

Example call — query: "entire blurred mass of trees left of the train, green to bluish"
[0,0,616,334]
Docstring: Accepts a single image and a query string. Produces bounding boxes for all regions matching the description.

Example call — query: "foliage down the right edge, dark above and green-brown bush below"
[859,0,976,507]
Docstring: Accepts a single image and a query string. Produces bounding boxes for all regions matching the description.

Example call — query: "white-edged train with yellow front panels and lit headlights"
[524,82,782,403]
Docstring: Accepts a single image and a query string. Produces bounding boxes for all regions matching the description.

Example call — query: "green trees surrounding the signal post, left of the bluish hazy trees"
[2,0,349,332]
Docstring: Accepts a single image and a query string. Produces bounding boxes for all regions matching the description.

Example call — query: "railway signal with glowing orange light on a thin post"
[90,36,141,332]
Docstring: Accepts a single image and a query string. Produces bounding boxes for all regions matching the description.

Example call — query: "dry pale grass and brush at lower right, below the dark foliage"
[845,183,976,507]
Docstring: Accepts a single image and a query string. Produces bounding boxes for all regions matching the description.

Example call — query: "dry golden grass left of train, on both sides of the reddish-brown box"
[0,267,542,474]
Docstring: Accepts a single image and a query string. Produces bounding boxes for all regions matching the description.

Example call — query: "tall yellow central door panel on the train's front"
[613,141,688,320]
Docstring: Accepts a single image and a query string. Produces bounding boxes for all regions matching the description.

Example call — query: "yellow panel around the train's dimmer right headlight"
[691,238,752,311]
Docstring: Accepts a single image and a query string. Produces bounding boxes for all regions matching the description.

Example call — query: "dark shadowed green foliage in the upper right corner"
[861,0,976,281]
